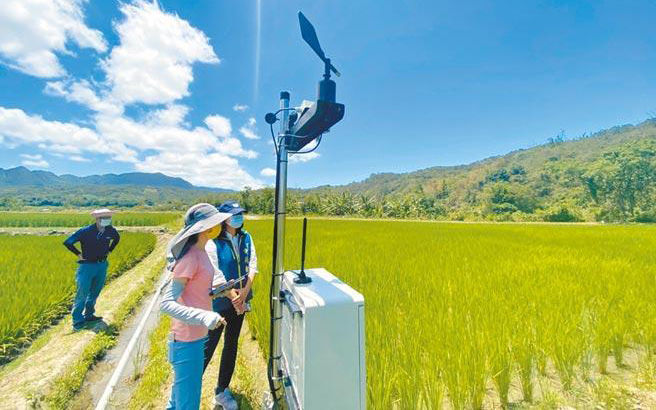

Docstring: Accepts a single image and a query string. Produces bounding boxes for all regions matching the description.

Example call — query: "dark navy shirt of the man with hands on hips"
[64,224,121,262]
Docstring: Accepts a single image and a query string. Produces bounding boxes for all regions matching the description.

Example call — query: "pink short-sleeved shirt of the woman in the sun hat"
[171,246,214,342]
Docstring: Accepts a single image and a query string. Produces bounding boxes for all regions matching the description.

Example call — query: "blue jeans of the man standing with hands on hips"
[73,261,107,327]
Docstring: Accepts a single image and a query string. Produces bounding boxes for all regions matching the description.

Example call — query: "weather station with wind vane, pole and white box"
[265,12,366,410]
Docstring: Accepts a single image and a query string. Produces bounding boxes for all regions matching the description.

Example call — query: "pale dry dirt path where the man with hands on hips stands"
[0,235,169,409]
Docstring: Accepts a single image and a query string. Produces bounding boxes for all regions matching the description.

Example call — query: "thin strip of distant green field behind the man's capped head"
[0,212,180,228]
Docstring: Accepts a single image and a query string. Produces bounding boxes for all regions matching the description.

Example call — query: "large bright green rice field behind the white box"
[246,220,656,409]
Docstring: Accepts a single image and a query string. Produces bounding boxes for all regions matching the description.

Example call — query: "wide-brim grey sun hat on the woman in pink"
[166,203,232,261]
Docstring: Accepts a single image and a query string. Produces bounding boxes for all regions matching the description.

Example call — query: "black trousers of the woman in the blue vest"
[203,306,244,394]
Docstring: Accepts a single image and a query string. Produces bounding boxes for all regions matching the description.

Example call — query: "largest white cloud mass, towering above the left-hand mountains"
[0,0,263,189]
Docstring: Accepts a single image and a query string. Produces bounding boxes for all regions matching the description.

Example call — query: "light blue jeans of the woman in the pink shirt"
[166,337,207,410]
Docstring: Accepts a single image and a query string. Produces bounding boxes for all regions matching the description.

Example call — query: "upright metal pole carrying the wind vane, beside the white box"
[269,91,289,408]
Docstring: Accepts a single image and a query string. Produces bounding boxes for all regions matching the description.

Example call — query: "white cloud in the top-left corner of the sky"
[0,0,107,78]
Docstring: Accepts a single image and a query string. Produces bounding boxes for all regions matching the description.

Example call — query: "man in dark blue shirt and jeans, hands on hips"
[64,209,121,330]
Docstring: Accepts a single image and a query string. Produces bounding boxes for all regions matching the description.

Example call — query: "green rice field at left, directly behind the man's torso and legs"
[0,232,156,364]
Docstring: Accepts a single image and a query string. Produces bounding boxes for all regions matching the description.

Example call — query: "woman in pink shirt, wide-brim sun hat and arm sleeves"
[160,204,230,410]
